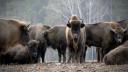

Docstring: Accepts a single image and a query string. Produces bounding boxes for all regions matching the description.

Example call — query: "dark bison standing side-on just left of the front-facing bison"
[44,26,67,62]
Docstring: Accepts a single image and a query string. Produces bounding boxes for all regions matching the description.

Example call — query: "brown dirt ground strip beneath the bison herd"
[0,62,128,72]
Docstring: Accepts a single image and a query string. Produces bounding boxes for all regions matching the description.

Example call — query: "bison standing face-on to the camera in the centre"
[65,16,86,63]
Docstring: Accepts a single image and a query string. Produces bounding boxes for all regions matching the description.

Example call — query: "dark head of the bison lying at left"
[27,40,39,60]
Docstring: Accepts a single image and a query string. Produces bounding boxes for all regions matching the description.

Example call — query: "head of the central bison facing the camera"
[67,16,85,42]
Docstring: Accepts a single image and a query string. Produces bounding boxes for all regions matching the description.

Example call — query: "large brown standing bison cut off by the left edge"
[0,19,29,63]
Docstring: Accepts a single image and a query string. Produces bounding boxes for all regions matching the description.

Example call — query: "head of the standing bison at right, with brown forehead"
[110,23,127,43]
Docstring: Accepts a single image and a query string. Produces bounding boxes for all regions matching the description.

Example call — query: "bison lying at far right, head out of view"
[103,41,128,65]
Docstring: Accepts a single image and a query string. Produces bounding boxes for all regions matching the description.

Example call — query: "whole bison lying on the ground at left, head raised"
[1,40,38,64]
